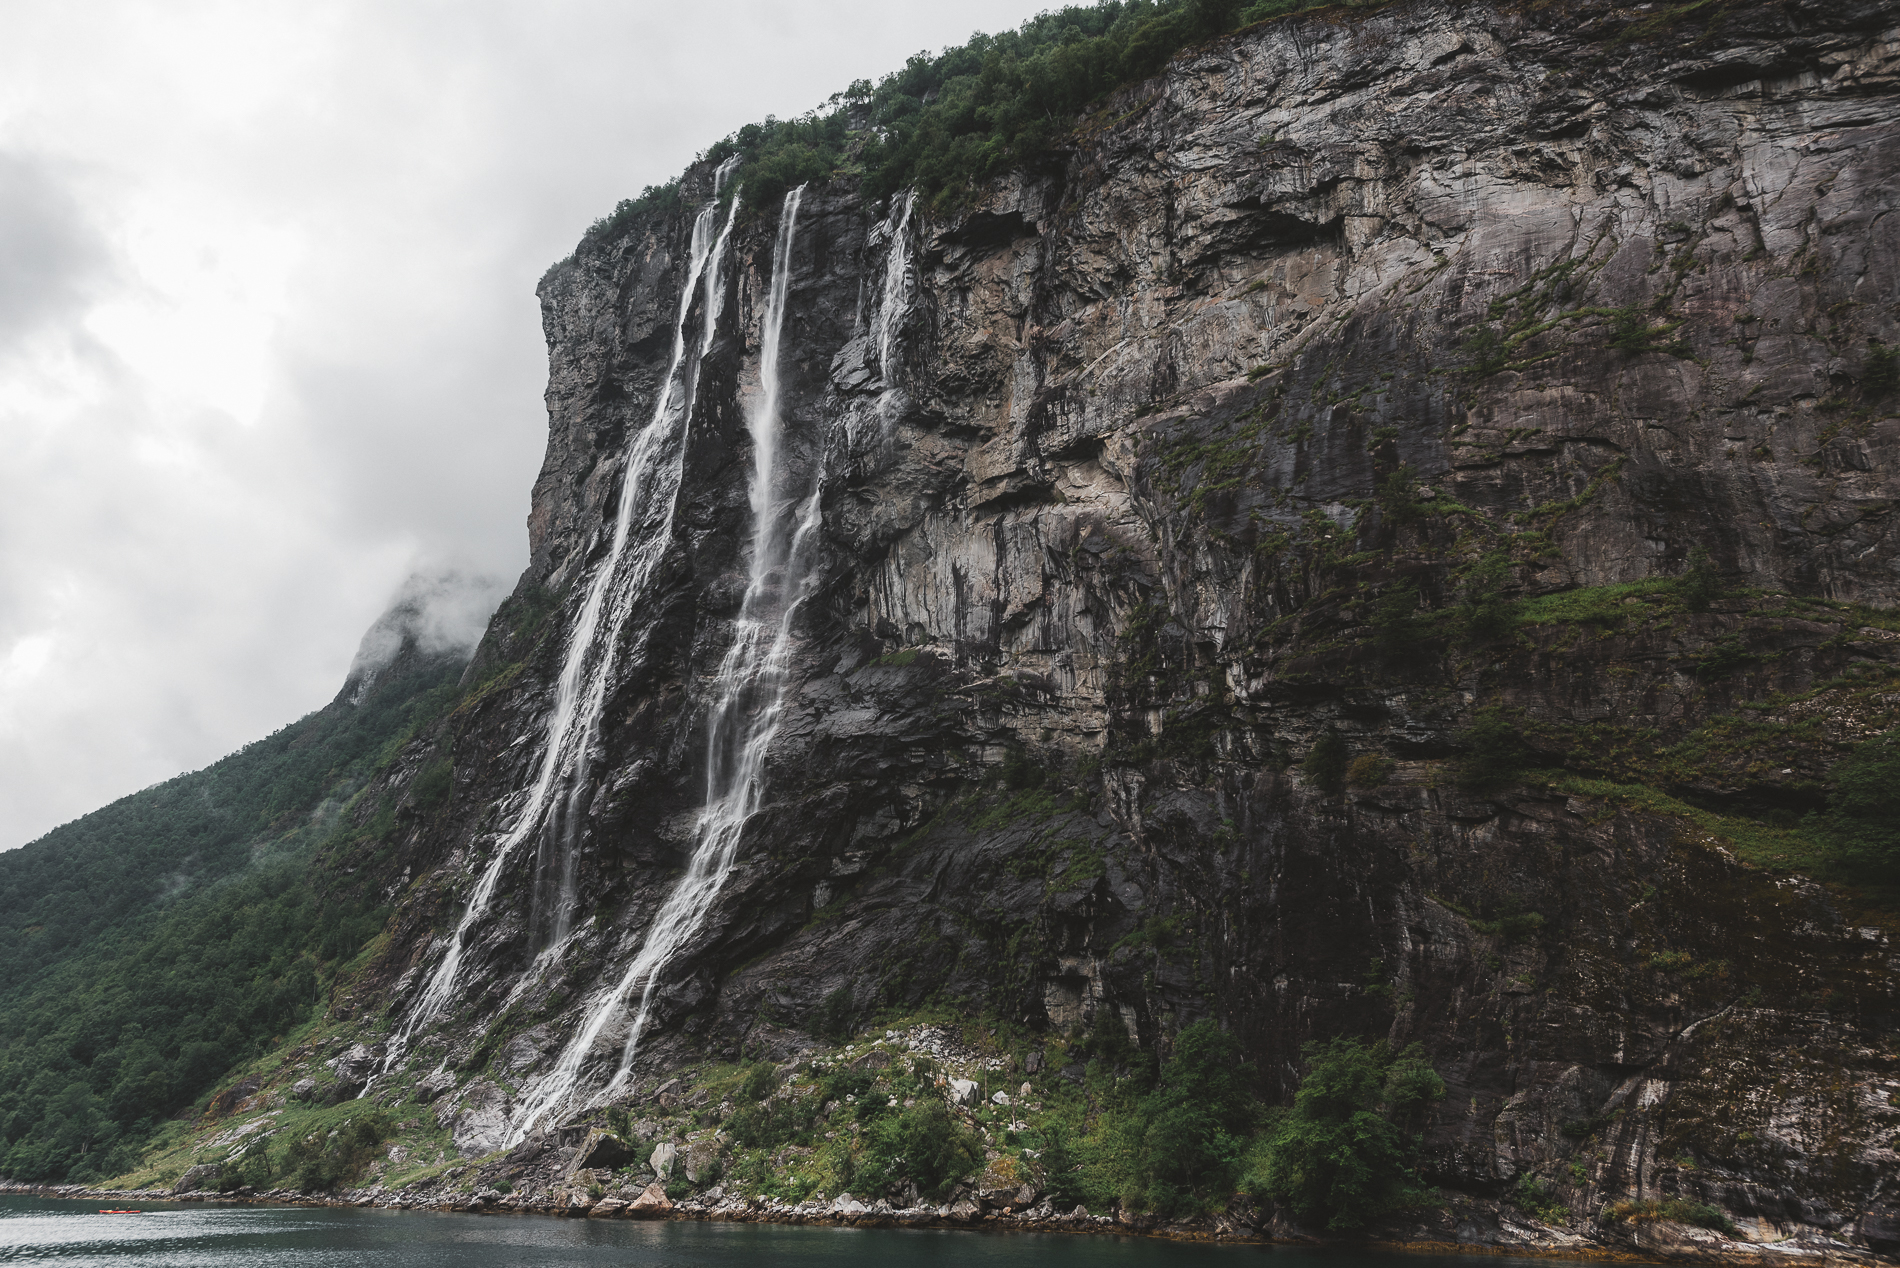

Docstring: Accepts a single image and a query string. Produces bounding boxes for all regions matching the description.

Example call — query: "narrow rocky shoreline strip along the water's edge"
[0,1181,1896,1268]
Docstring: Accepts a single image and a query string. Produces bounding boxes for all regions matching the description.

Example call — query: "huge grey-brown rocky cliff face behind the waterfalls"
[307,0,1900,1245]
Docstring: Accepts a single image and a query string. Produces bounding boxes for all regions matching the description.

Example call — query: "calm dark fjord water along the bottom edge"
[0,1198,1575,1268]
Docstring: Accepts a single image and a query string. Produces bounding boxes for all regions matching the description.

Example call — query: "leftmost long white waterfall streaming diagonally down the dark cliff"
[384,158,739,1070]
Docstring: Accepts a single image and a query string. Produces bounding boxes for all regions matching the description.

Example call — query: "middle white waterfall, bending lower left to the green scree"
[513,186,823,1141]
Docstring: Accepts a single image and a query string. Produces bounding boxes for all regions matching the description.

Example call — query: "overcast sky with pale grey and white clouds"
[0,0,1045,848]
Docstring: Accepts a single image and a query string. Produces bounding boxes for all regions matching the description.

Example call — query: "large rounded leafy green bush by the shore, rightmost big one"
[1246,1038,1444,1232]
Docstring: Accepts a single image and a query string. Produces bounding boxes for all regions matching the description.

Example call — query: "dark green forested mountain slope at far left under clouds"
[0,662,462,1181]
